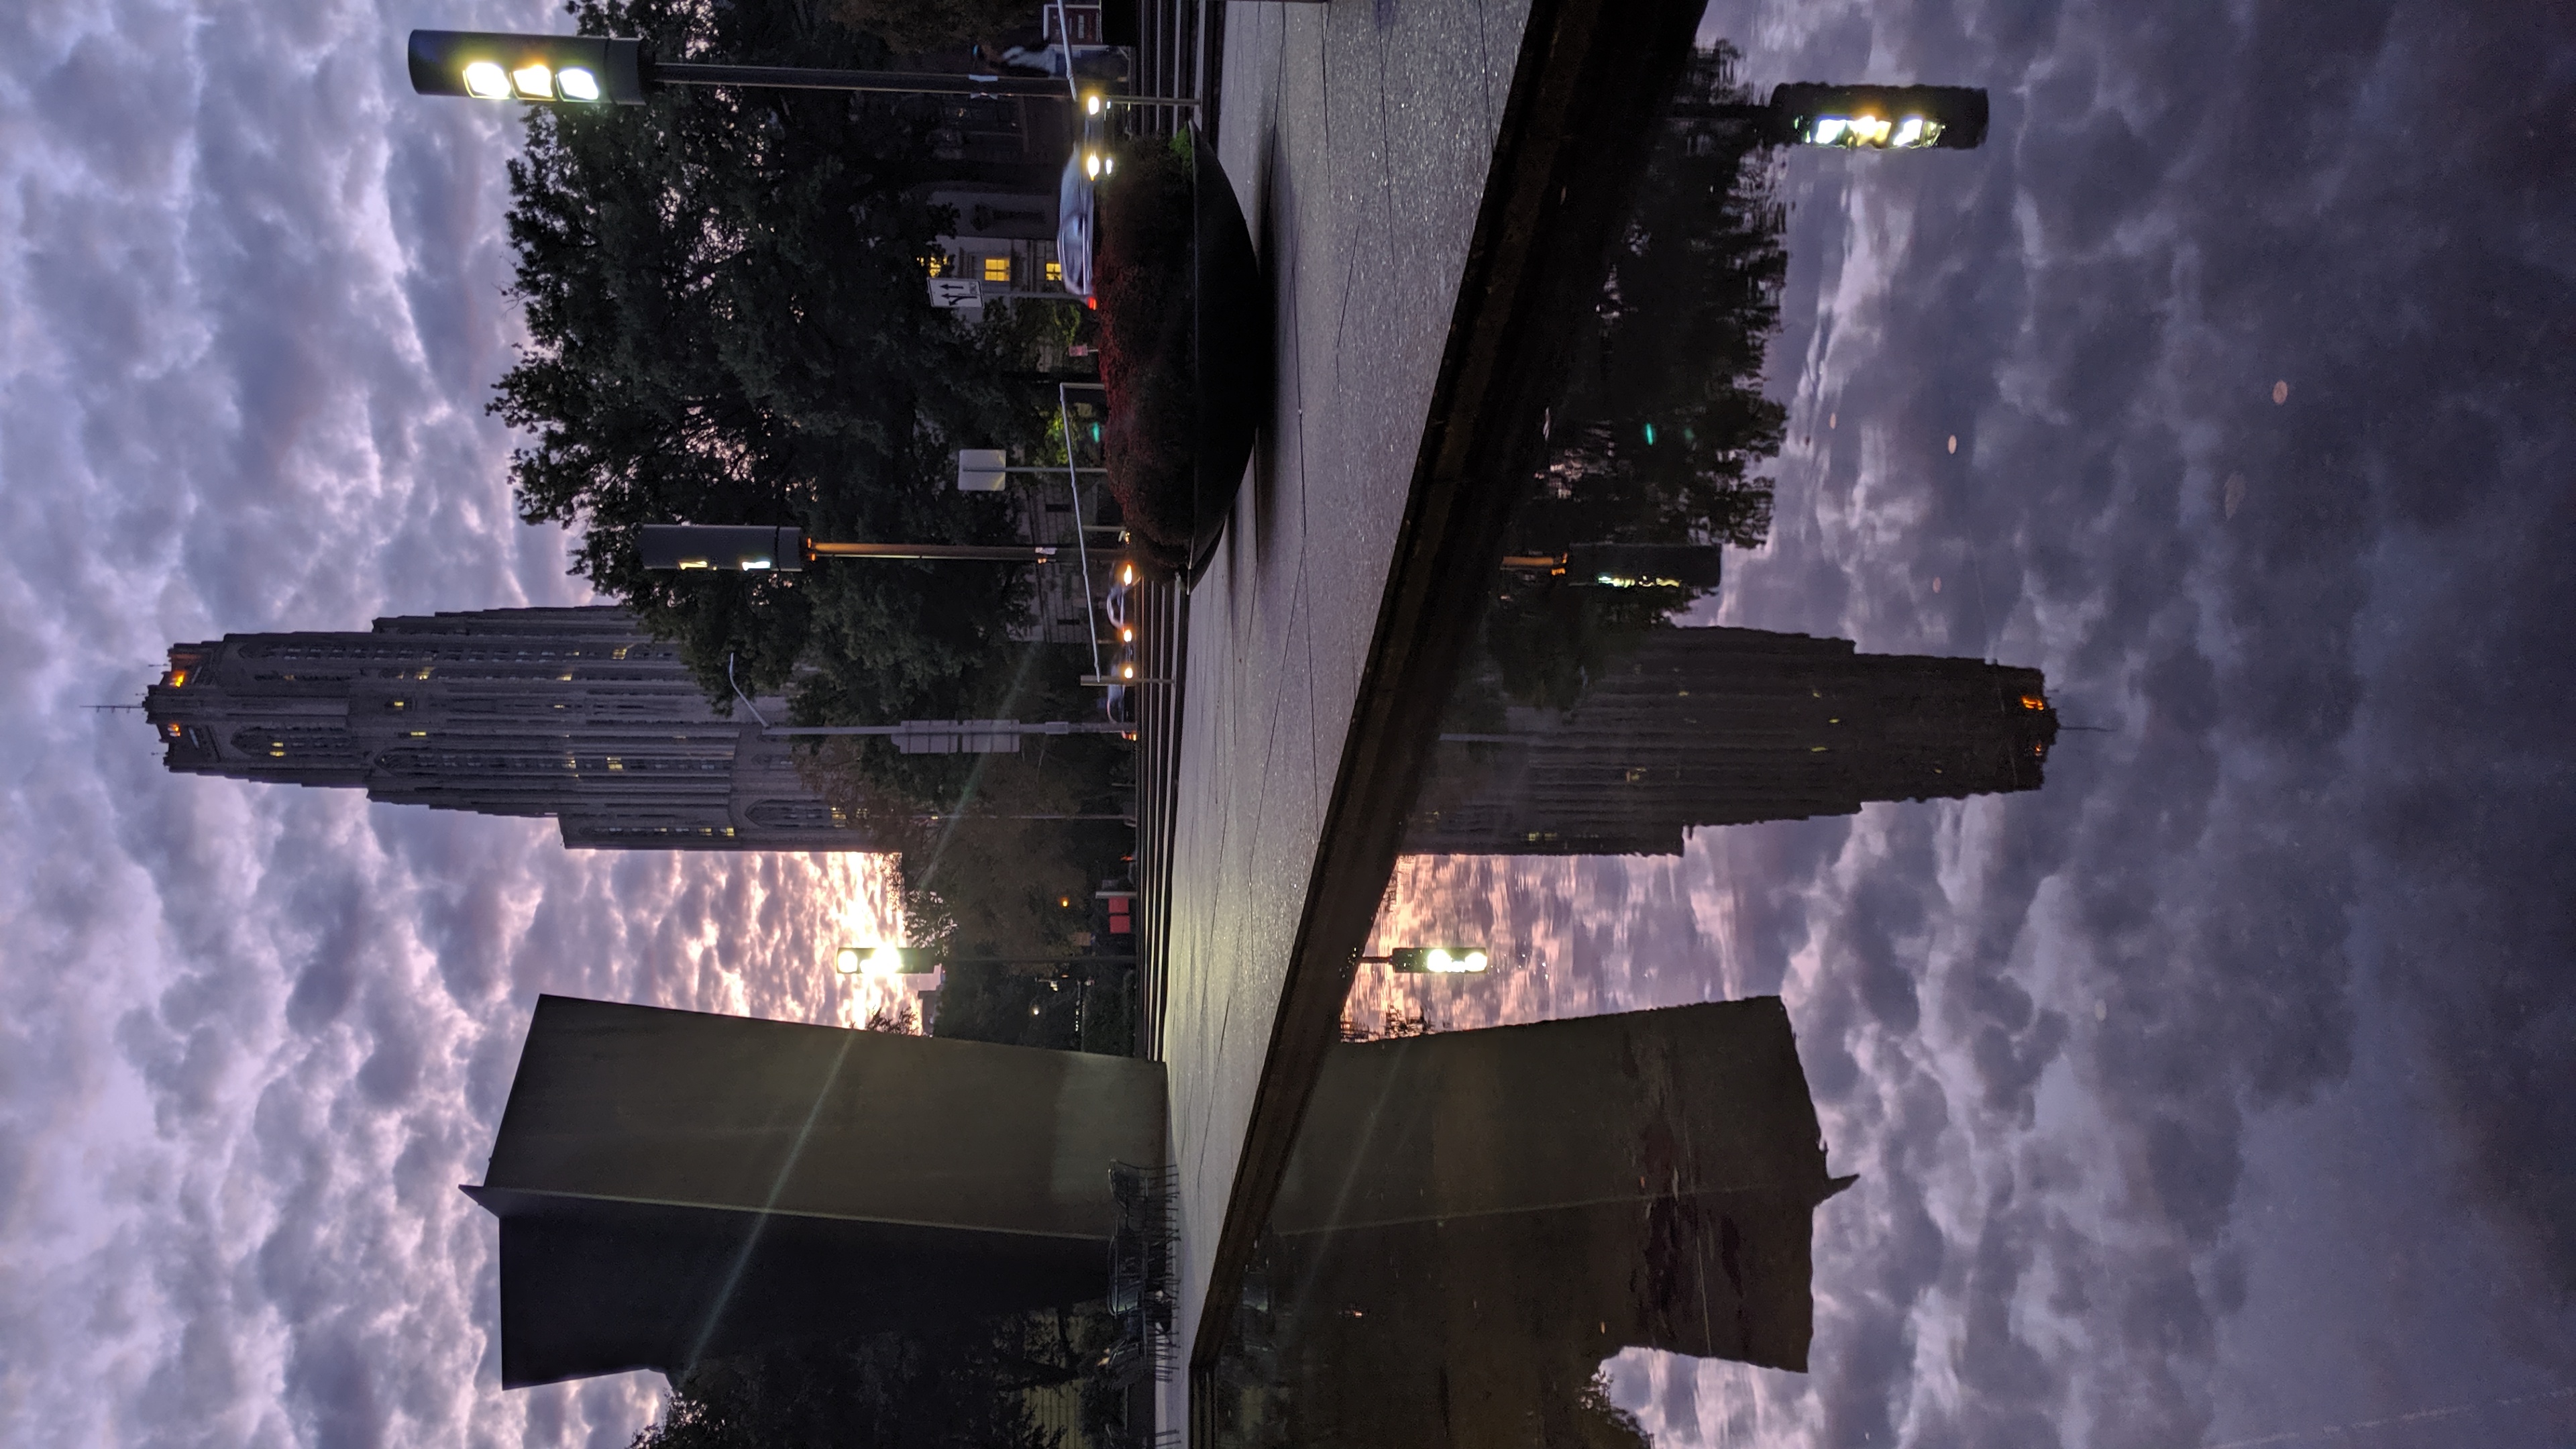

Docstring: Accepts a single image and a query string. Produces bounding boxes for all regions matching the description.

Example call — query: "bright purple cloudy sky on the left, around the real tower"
[0,0,906,1446]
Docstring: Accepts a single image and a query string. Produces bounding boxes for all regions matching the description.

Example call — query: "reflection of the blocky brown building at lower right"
[1242,998,1852,1444]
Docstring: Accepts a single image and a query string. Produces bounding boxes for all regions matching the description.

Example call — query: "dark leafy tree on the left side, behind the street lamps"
[492,0,1038,722]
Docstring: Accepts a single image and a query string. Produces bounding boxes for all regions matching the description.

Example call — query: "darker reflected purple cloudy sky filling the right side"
[1362,0,2576,1449]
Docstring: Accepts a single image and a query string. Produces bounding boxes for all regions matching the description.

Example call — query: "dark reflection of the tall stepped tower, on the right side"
[1404,629,2058,856]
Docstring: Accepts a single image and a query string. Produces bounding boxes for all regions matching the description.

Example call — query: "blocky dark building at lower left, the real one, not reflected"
[464,996,1165,1387]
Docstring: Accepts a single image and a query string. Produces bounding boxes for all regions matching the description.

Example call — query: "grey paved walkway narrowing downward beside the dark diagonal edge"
[1162,0,1527,1426]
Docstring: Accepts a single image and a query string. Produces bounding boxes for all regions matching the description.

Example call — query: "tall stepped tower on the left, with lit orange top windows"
[144,608,881,851]
